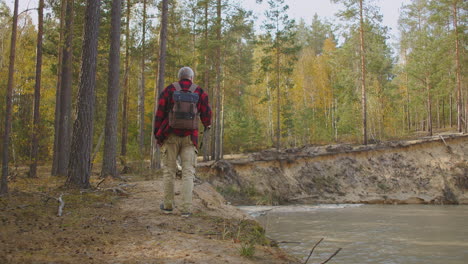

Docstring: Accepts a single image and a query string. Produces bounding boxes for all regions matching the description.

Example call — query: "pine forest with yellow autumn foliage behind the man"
[0,0,468,179]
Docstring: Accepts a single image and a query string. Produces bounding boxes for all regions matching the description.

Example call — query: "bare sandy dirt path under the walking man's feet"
[110,181,291,264]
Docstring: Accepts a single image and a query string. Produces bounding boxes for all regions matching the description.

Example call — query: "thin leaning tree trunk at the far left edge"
[0,0,19,195]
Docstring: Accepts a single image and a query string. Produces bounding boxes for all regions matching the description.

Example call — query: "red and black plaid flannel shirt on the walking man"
[153,79,211,147]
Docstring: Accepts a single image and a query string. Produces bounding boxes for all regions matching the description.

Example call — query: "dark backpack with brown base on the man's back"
[169,82,200,129]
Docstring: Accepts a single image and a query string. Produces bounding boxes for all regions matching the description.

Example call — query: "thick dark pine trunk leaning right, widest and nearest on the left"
[66,0,100,188]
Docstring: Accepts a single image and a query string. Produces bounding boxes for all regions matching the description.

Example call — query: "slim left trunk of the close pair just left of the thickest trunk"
[51,0,67,175]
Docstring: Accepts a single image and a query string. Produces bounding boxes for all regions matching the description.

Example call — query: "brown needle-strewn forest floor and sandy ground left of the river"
[0,167,299,264]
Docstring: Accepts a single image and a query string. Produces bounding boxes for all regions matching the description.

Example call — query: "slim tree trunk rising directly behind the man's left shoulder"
[151,0,168,169]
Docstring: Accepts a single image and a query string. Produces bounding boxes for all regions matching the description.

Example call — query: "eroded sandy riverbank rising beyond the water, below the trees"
[199,134,468,204]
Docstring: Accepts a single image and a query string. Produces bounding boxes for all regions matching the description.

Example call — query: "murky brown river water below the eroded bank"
[241,205,468,264]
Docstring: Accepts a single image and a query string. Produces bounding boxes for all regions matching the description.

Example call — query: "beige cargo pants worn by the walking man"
[161,134,197,213]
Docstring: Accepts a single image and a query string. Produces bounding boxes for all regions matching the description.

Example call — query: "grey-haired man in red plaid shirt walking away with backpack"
[154,67,211,217]
